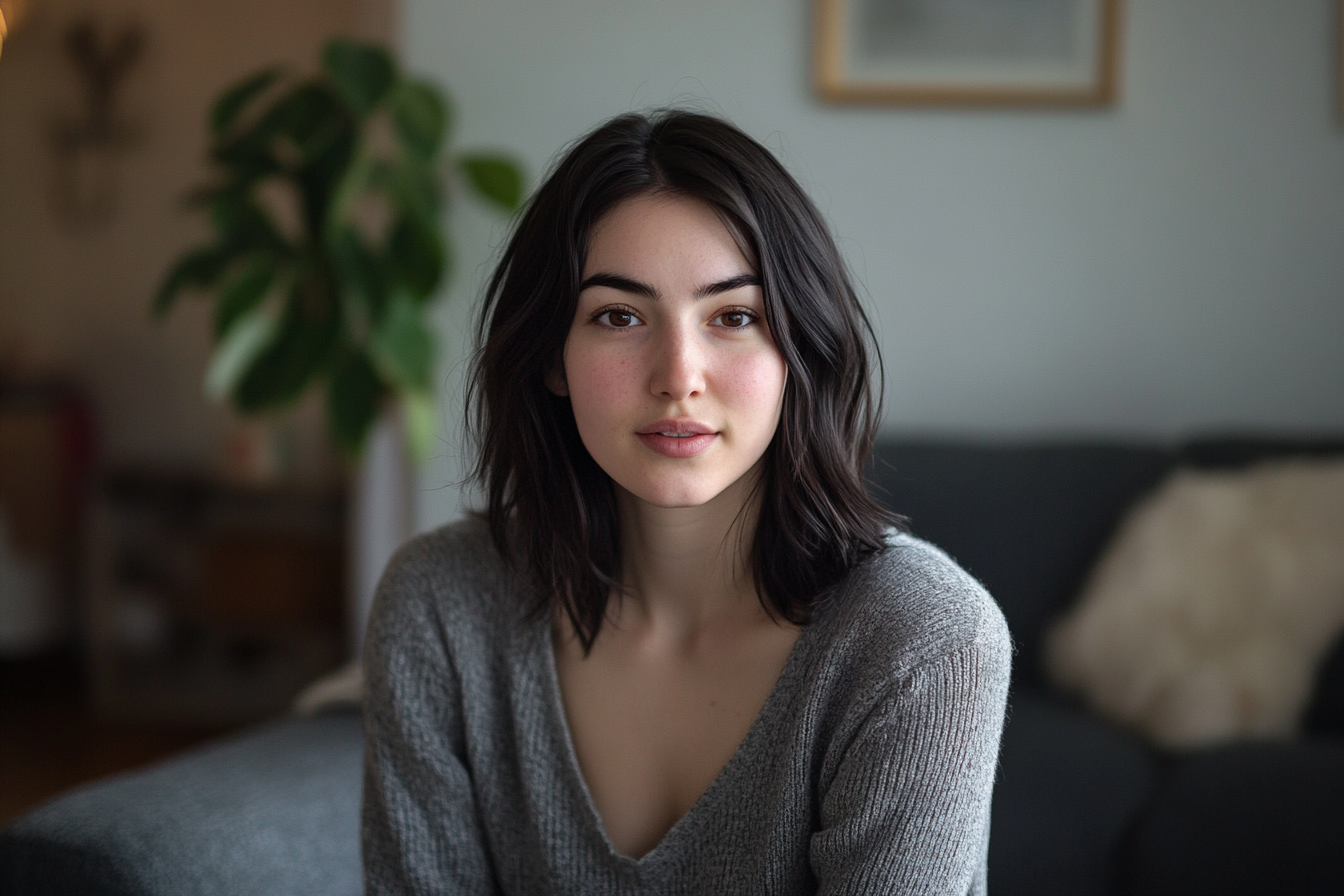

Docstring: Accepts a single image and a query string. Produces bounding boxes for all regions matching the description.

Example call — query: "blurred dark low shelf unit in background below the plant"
[85,467,345,727]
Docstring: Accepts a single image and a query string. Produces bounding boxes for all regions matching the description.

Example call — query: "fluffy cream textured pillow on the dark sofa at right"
[1046,459,1344,748]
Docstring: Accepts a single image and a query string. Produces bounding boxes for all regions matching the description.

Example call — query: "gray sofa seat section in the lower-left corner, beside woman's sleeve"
[0,712,363,896]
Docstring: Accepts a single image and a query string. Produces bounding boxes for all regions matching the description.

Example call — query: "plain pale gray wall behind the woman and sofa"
[403,0,1344,527]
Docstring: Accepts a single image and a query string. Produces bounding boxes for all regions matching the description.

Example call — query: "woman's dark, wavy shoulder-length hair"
[468,110,894,650]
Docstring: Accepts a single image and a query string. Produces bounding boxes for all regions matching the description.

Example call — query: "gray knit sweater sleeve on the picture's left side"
[362,548,497,896]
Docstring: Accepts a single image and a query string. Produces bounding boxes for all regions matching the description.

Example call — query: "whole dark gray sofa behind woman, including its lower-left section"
[0,439,1344,896]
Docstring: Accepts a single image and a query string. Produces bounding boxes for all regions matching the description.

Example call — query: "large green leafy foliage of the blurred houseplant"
[153,39,523,458]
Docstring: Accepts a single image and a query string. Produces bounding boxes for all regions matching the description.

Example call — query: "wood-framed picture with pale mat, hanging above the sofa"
[813,0,1121,106]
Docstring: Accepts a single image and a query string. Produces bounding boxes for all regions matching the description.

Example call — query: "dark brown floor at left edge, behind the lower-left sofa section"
[0,650,232,825]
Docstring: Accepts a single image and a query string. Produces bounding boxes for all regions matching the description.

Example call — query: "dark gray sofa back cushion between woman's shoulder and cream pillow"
[870,439,1175,684]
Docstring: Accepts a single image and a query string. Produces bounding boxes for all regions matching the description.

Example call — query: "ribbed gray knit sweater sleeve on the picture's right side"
[809,615,1011,896]
